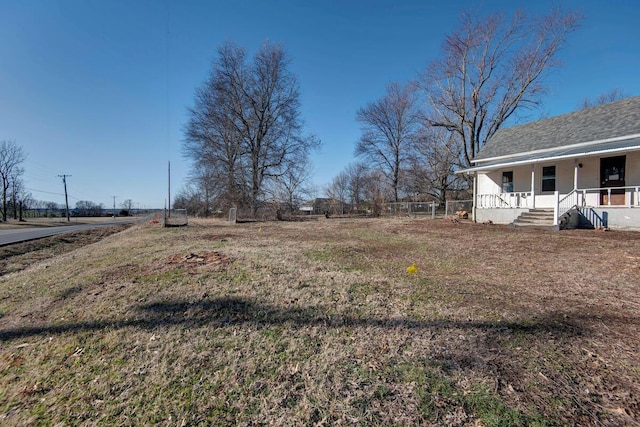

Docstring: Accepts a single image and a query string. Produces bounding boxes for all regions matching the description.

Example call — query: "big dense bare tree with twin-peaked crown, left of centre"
[185,43,319,214]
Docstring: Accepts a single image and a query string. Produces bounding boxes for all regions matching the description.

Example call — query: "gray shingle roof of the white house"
[474,96,640,160]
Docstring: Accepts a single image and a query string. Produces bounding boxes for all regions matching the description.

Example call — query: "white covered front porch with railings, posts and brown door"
[461,138,640,228]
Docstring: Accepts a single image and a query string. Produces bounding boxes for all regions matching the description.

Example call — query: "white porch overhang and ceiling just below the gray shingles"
[456,138,640,173]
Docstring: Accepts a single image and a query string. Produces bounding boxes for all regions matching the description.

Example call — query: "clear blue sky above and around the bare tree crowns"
[0,0,640,208]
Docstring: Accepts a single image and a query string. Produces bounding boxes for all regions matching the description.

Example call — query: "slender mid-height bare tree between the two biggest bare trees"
[355,83,421,201]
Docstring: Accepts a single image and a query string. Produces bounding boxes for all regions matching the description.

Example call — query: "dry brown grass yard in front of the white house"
[0,219,640,426]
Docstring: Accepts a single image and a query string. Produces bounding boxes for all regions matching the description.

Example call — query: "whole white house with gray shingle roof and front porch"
[458,96,640,229]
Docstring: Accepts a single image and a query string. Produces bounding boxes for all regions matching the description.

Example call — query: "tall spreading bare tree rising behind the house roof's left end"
[421,9,580,166]
